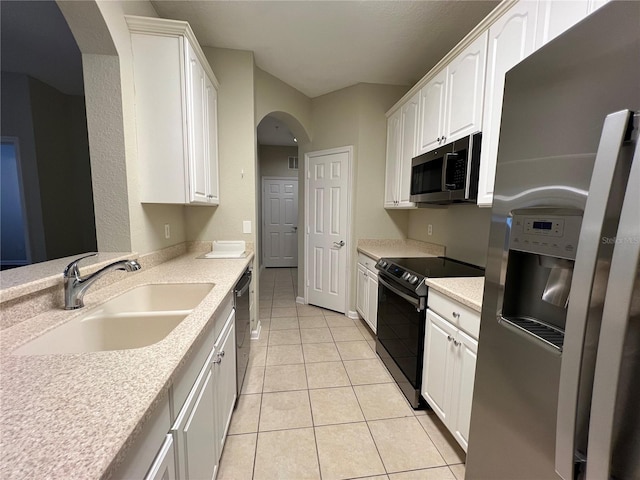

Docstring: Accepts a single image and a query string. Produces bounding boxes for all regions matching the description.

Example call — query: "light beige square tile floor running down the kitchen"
[218,268,465,480]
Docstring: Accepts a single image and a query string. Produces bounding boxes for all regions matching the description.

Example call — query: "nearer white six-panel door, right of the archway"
[305,147,352,313]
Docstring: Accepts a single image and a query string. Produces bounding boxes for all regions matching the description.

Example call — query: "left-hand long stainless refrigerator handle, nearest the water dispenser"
[556,110,633,480]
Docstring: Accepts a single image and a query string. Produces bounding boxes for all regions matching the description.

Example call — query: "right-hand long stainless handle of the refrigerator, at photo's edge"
[587,129,640,478]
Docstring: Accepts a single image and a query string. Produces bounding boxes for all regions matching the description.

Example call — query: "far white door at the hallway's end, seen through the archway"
[262,177,298,267]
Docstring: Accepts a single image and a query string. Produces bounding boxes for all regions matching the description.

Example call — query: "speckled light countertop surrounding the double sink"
[0,252,253,480]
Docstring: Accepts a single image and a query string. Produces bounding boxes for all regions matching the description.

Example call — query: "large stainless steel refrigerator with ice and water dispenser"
[466,1,640,480]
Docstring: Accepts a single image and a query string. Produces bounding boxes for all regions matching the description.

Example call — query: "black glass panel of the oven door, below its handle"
[377,285,425,389]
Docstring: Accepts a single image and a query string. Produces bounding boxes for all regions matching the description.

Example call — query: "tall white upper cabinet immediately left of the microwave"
[384,94,419,208]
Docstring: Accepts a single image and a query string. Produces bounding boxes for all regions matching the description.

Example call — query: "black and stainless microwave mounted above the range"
[410,132,482,206]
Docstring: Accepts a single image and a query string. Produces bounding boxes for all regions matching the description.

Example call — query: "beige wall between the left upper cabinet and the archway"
[185,47,256,243]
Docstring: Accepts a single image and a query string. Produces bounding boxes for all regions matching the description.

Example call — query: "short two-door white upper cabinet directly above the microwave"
[417,32,487,154]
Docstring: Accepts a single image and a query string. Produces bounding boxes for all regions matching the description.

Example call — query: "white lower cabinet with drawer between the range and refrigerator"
[421,291,480,451]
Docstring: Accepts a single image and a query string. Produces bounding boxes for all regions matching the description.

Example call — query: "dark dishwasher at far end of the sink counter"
[233,268,251,404]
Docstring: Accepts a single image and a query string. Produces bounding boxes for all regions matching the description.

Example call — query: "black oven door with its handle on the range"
[376,274,426,408]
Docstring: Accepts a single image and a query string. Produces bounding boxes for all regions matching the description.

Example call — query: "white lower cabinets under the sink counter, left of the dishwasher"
[112,294,237,480]
